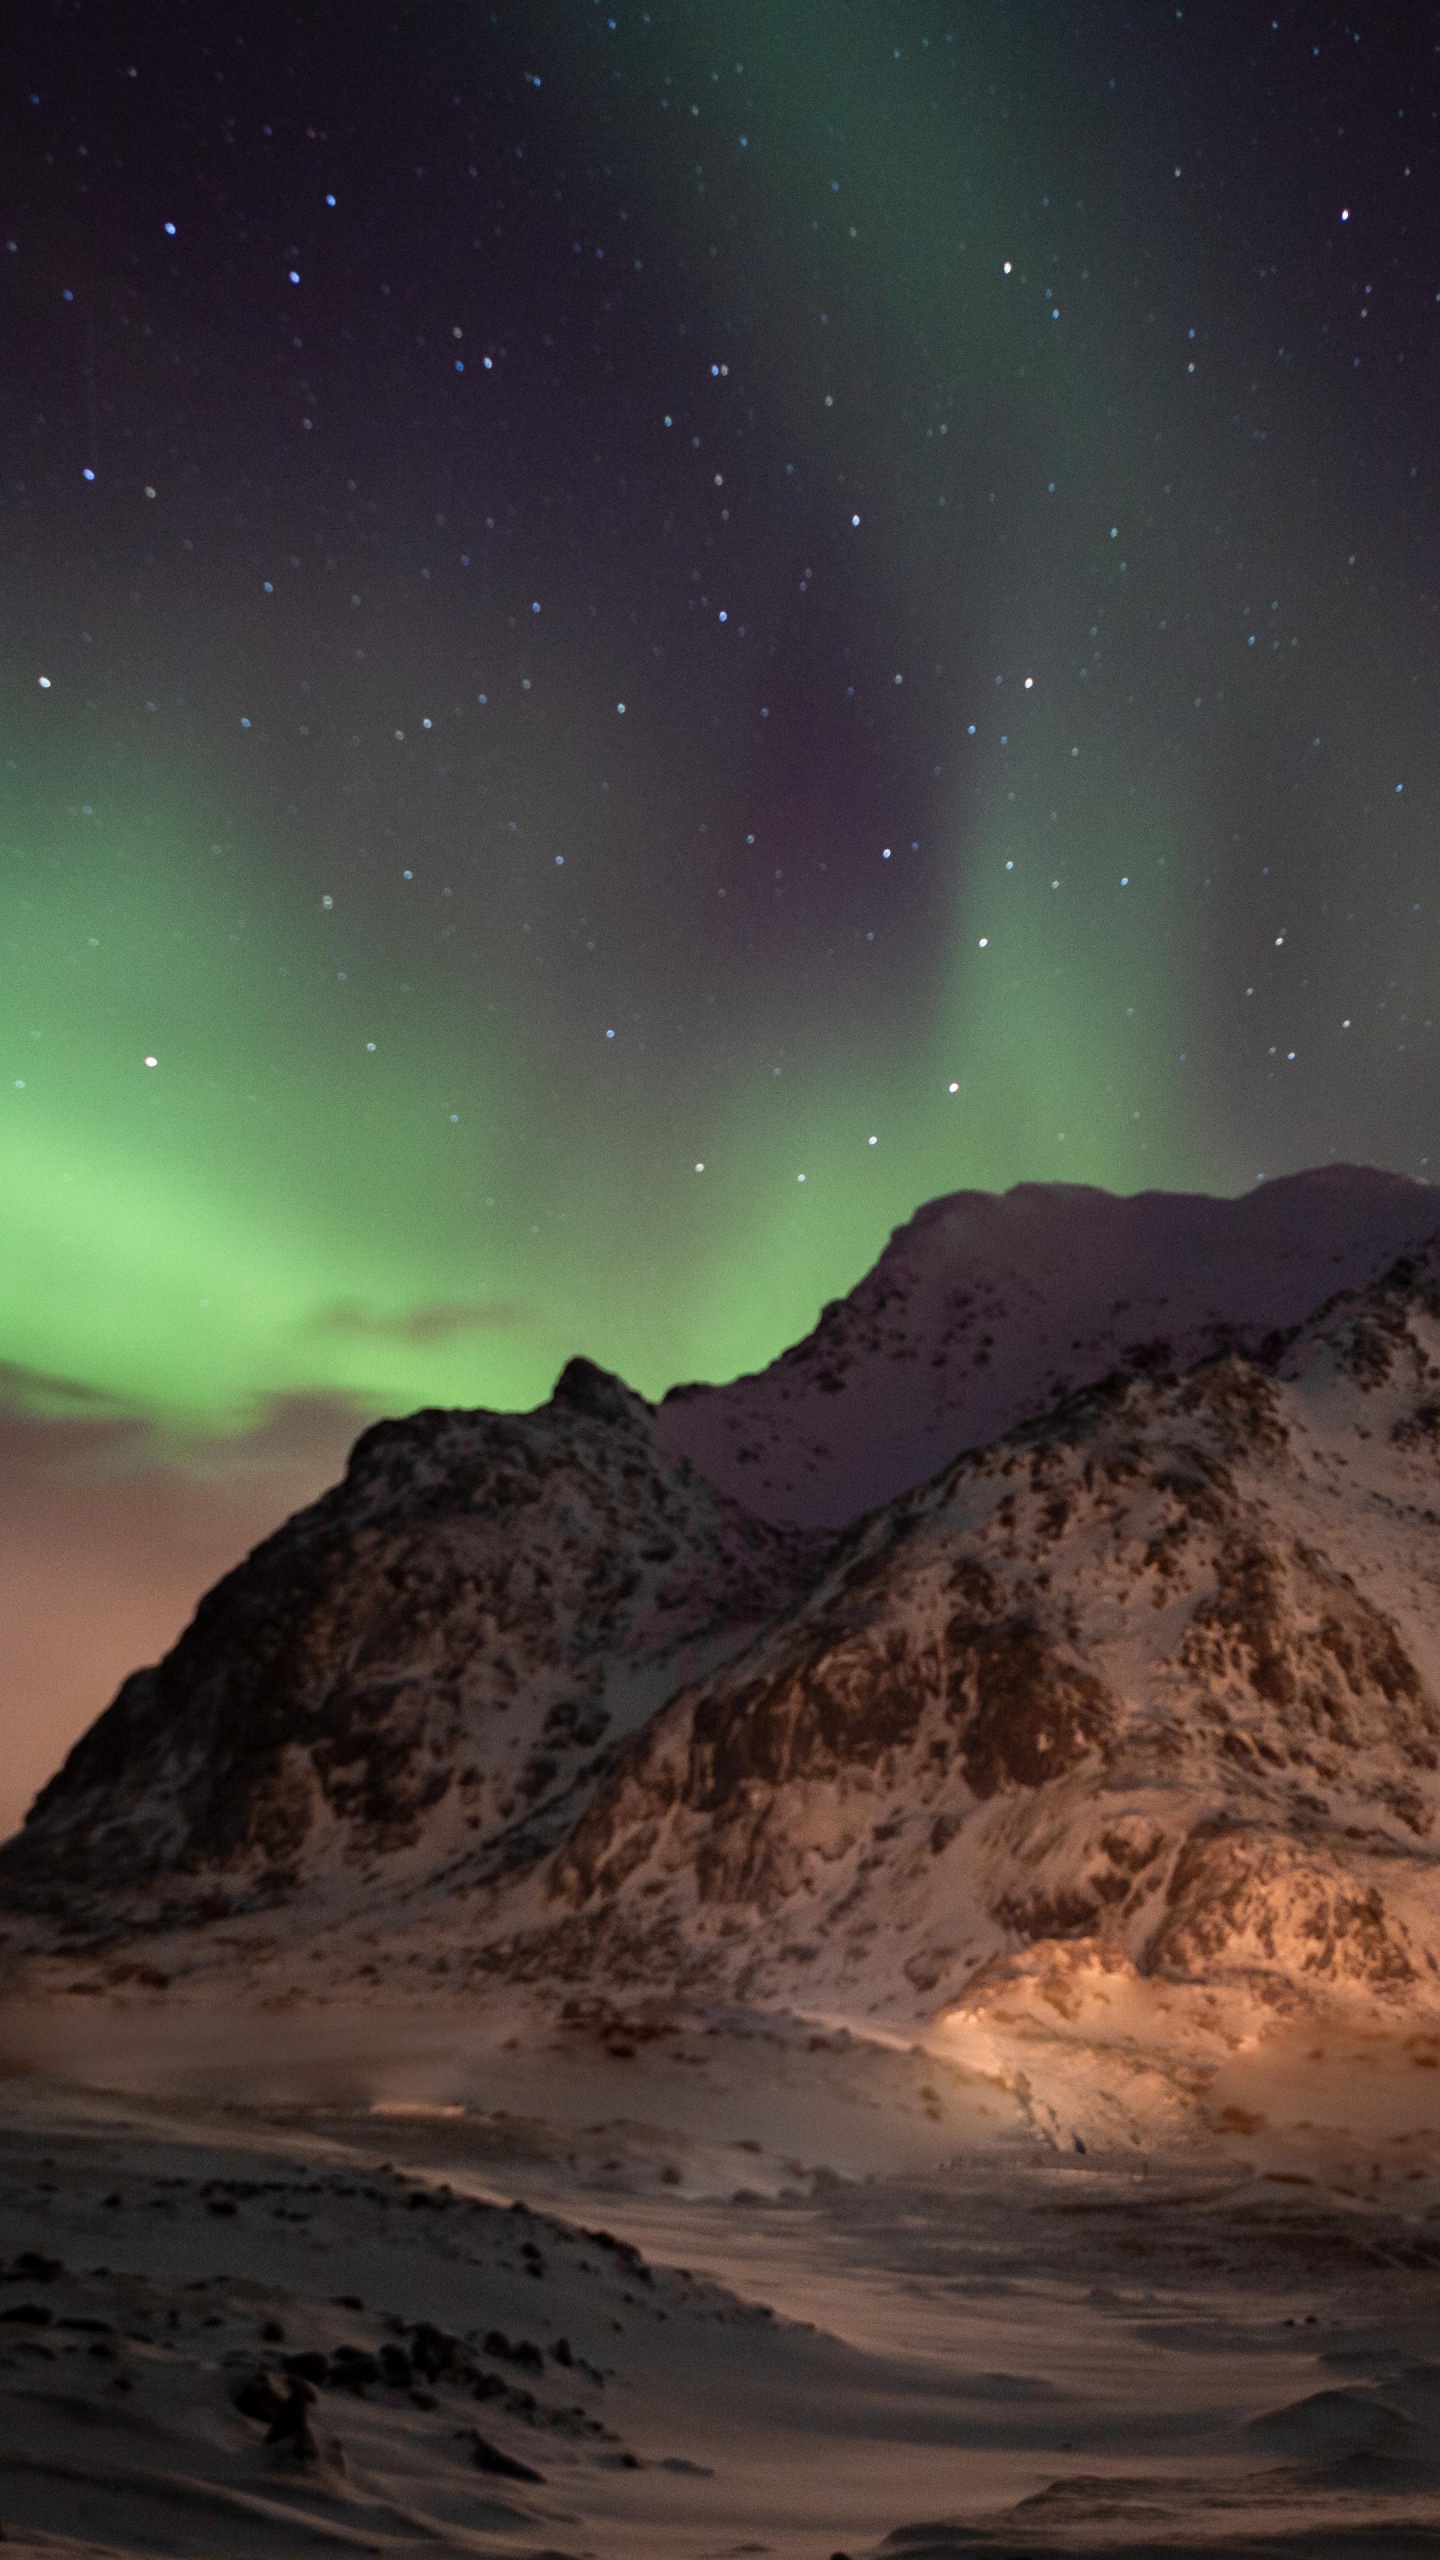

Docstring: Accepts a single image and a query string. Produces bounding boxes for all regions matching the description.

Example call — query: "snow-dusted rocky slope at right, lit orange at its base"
[502,1254,1440,2017]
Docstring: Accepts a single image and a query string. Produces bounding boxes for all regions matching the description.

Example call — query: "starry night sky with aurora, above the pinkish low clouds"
[0,0,1440,1434]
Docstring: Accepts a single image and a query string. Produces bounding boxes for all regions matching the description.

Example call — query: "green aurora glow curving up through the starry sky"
[0,8,1422,1434]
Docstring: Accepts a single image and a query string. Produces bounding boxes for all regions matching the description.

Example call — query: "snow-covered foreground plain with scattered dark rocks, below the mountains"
[0,2002,1440,2560]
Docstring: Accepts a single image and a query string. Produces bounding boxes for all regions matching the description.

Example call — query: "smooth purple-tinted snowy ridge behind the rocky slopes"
[656,1165,1440,1528]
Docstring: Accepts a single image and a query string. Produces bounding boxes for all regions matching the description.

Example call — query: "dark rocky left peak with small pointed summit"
[0,1362,815,1915]
